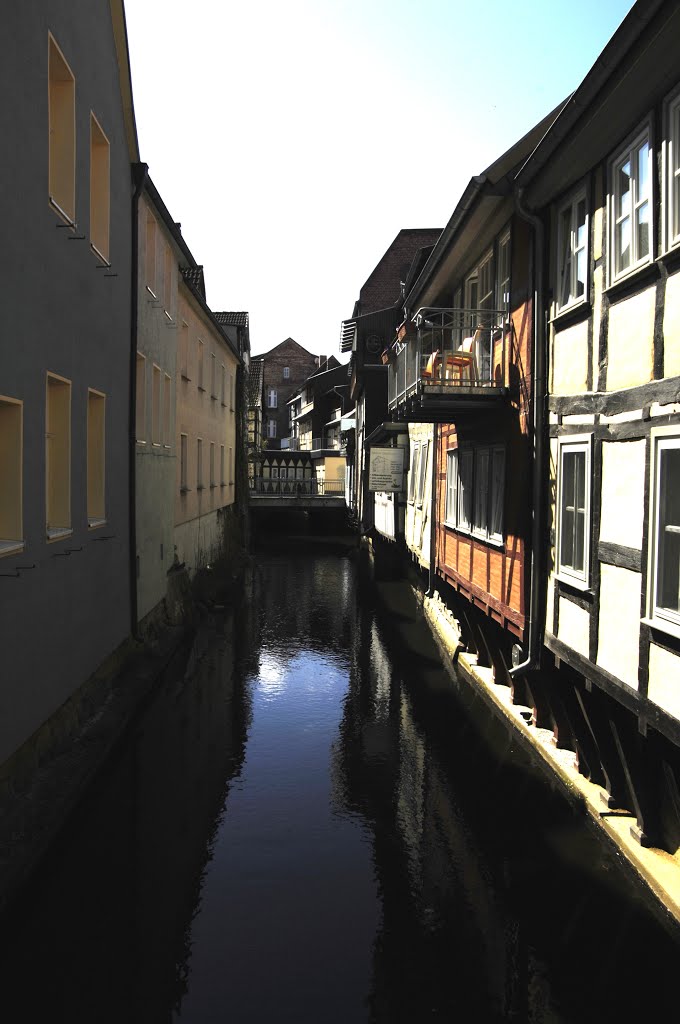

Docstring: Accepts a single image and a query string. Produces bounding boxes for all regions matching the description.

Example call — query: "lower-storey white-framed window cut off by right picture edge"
[649,428,680,627]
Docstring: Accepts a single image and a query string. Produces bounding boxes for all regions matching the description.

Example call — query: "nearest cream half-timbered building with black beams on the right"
[516,2,680,850]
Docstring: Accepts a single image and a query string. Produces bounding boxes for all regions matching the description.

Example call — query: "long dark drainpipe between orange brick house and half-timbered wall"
[509,188,547,678]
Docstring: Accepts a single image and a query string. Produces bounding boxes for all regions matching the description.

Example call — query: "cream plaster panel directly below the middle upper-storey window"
[606,287,655,391]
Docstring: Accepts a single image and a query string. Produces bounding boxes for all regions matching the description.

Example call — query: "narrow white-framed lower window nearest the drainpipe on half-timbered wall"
[557,435,592,586]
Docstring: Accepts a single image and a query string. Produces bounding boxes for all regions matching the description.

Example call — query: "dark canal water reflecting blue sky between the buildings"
[0,543,680,1024]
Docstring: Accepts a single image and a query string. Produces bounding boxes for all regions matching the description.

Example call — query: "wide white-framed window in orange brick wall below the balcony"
[445,445,505,544]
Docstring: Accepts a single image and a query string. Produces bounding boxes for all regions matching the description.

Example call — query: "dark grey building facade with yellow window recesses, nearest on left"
[0,0,138,764]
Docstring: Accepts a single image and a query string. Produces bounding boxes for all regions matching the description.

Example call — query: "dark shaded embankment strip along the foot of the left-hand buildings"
[0,557,246,912]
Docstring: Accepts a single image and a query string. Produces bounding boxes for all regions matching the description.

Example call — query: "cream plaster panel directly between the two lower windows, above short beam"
[600,440,645,548]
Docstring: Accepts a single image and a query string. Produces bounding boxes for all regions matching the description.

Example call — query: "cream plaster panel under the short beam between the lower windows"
[597,565,641,689]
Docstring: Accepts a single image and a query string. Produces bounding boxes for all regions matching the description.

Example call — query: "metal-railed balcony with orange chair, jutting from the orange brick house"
[387,306,513,423]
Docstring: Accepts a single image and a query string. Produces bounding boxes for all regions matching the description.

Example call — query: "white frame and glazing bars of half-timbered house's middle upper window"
[607,120,654,285]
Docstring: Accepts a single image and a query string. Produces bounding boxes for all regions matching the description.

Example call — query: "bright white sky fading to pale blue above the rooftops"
[126,0,631,355]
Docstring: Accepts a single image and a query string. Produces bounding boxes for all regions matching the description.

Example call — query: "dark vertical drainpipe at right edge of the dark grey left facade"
[128,164,148,641]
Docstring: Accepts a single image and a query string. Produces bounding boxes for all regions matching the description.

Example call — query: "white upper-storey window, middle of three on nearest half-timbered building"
[609,128,651,284]
